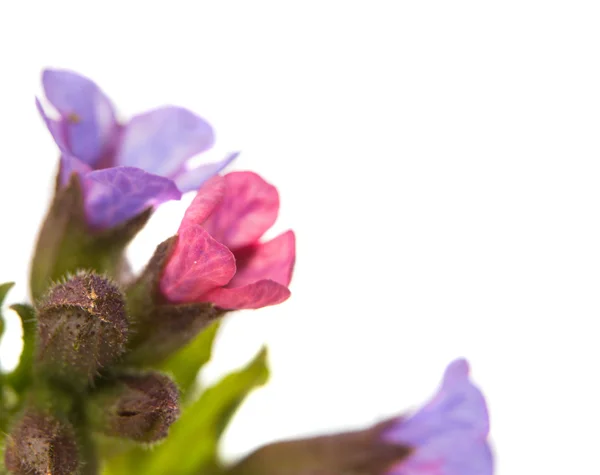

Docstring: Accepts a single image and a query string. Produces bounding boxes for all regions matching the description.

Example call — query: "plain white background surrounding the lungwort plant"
[0,0,600,475]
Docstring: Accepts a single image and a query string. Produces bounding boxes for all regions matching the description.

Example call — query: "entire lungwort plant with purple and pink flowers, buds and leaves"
[0,70,493,475]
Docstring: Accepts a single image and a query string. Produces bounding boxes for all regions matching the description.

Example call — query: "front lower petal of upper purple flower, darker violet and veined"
[83,167,181,229]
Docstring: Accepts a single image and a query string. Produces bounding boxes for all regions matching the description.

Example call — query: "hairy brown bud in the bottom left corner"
[4,410,79,475]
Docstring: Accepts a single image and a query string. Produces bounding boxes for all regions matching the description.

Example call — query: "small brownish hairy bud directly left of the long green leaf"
[88,373,179,442]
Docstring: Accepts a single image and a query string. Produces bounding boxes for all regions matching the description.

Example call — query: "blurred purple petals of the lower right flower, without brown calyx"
[383,360,493,475]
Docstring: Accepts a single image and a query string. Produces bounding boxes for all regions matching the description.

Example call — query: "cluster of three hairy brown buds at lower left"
[5,272,186,475]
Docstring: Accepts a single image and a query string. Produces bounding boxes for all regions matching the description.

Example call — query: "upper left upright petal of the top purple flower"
[42,69,117,165]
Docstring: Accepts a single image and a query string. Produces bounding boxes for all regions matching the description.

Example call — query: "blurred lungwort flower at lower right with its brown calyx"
[228,360,494,475]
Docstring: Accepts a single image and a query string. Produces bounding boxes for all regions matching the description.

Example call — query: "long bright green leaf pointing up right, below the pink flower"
[103,348,269,475]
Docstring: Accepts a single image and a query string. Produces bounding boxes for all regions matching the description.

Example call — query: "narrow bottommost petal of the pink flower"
[203,280,290,310]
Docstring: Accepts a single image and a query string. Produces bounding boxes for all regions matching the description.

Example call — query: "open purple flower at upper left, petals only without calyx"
[36,69,237,229]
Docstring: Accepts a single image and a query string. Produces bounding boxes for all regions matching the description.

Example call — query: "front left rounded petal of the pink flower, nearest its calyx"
[160,224,235,303]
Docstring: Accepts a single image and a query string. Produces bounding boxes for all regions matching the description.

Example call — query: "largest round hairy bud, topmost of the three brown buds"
[36,273,127,386]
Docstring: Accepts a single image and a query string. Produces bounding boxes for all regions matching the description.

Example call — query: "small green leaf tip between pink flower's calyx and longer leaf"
[158,321,220,396]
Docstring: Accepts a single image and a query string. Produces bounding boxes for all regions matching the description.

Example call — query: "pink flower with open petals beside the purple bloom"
[160,172,296,310]
